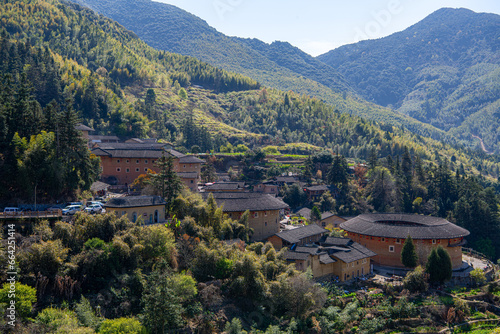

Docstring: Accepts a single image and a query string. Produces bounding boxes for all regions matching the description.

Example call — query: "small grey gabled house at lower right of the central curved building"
[267,224,330,250]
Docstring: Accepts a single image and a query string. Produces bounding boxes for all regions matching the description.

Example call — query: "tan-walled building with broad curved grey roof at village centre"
[202,192,288,241]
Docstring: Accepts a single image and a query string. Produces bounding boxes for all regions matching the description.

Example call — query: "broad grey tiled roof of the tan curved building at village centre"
[202,192,288,212]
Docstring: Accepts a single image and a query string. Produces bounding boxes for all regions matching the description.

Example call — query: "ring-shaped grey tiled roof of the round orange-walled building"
[340,213,470,239]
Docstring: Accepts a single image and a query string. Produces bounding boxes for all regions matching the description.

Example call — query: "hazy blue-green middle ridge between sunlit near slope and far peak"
[64,0,453,142]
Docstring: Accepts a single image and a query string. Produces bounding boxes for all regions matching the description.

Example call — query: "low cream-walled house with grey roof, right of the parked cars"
[104,196,166,224]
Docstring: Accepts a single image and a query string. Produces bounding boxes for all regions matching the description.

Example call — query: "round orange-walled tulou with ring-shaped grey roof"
[340,213,469,269]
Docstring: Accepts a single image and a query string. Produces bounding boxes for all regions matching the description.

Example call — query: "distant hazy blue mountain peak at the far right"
[317,8,500,152]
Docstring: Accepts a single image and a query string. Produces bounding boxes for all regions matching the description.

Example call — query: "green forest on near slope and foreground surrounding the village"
[0,0,500,334]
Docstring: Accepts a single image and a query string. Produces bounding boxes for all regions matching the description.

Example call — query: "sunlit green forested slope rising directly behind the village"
[0,0,498,197]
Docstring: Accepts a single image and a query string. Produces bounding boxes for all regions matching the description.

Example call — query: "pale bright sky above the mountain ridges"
[156,0,500,56]
